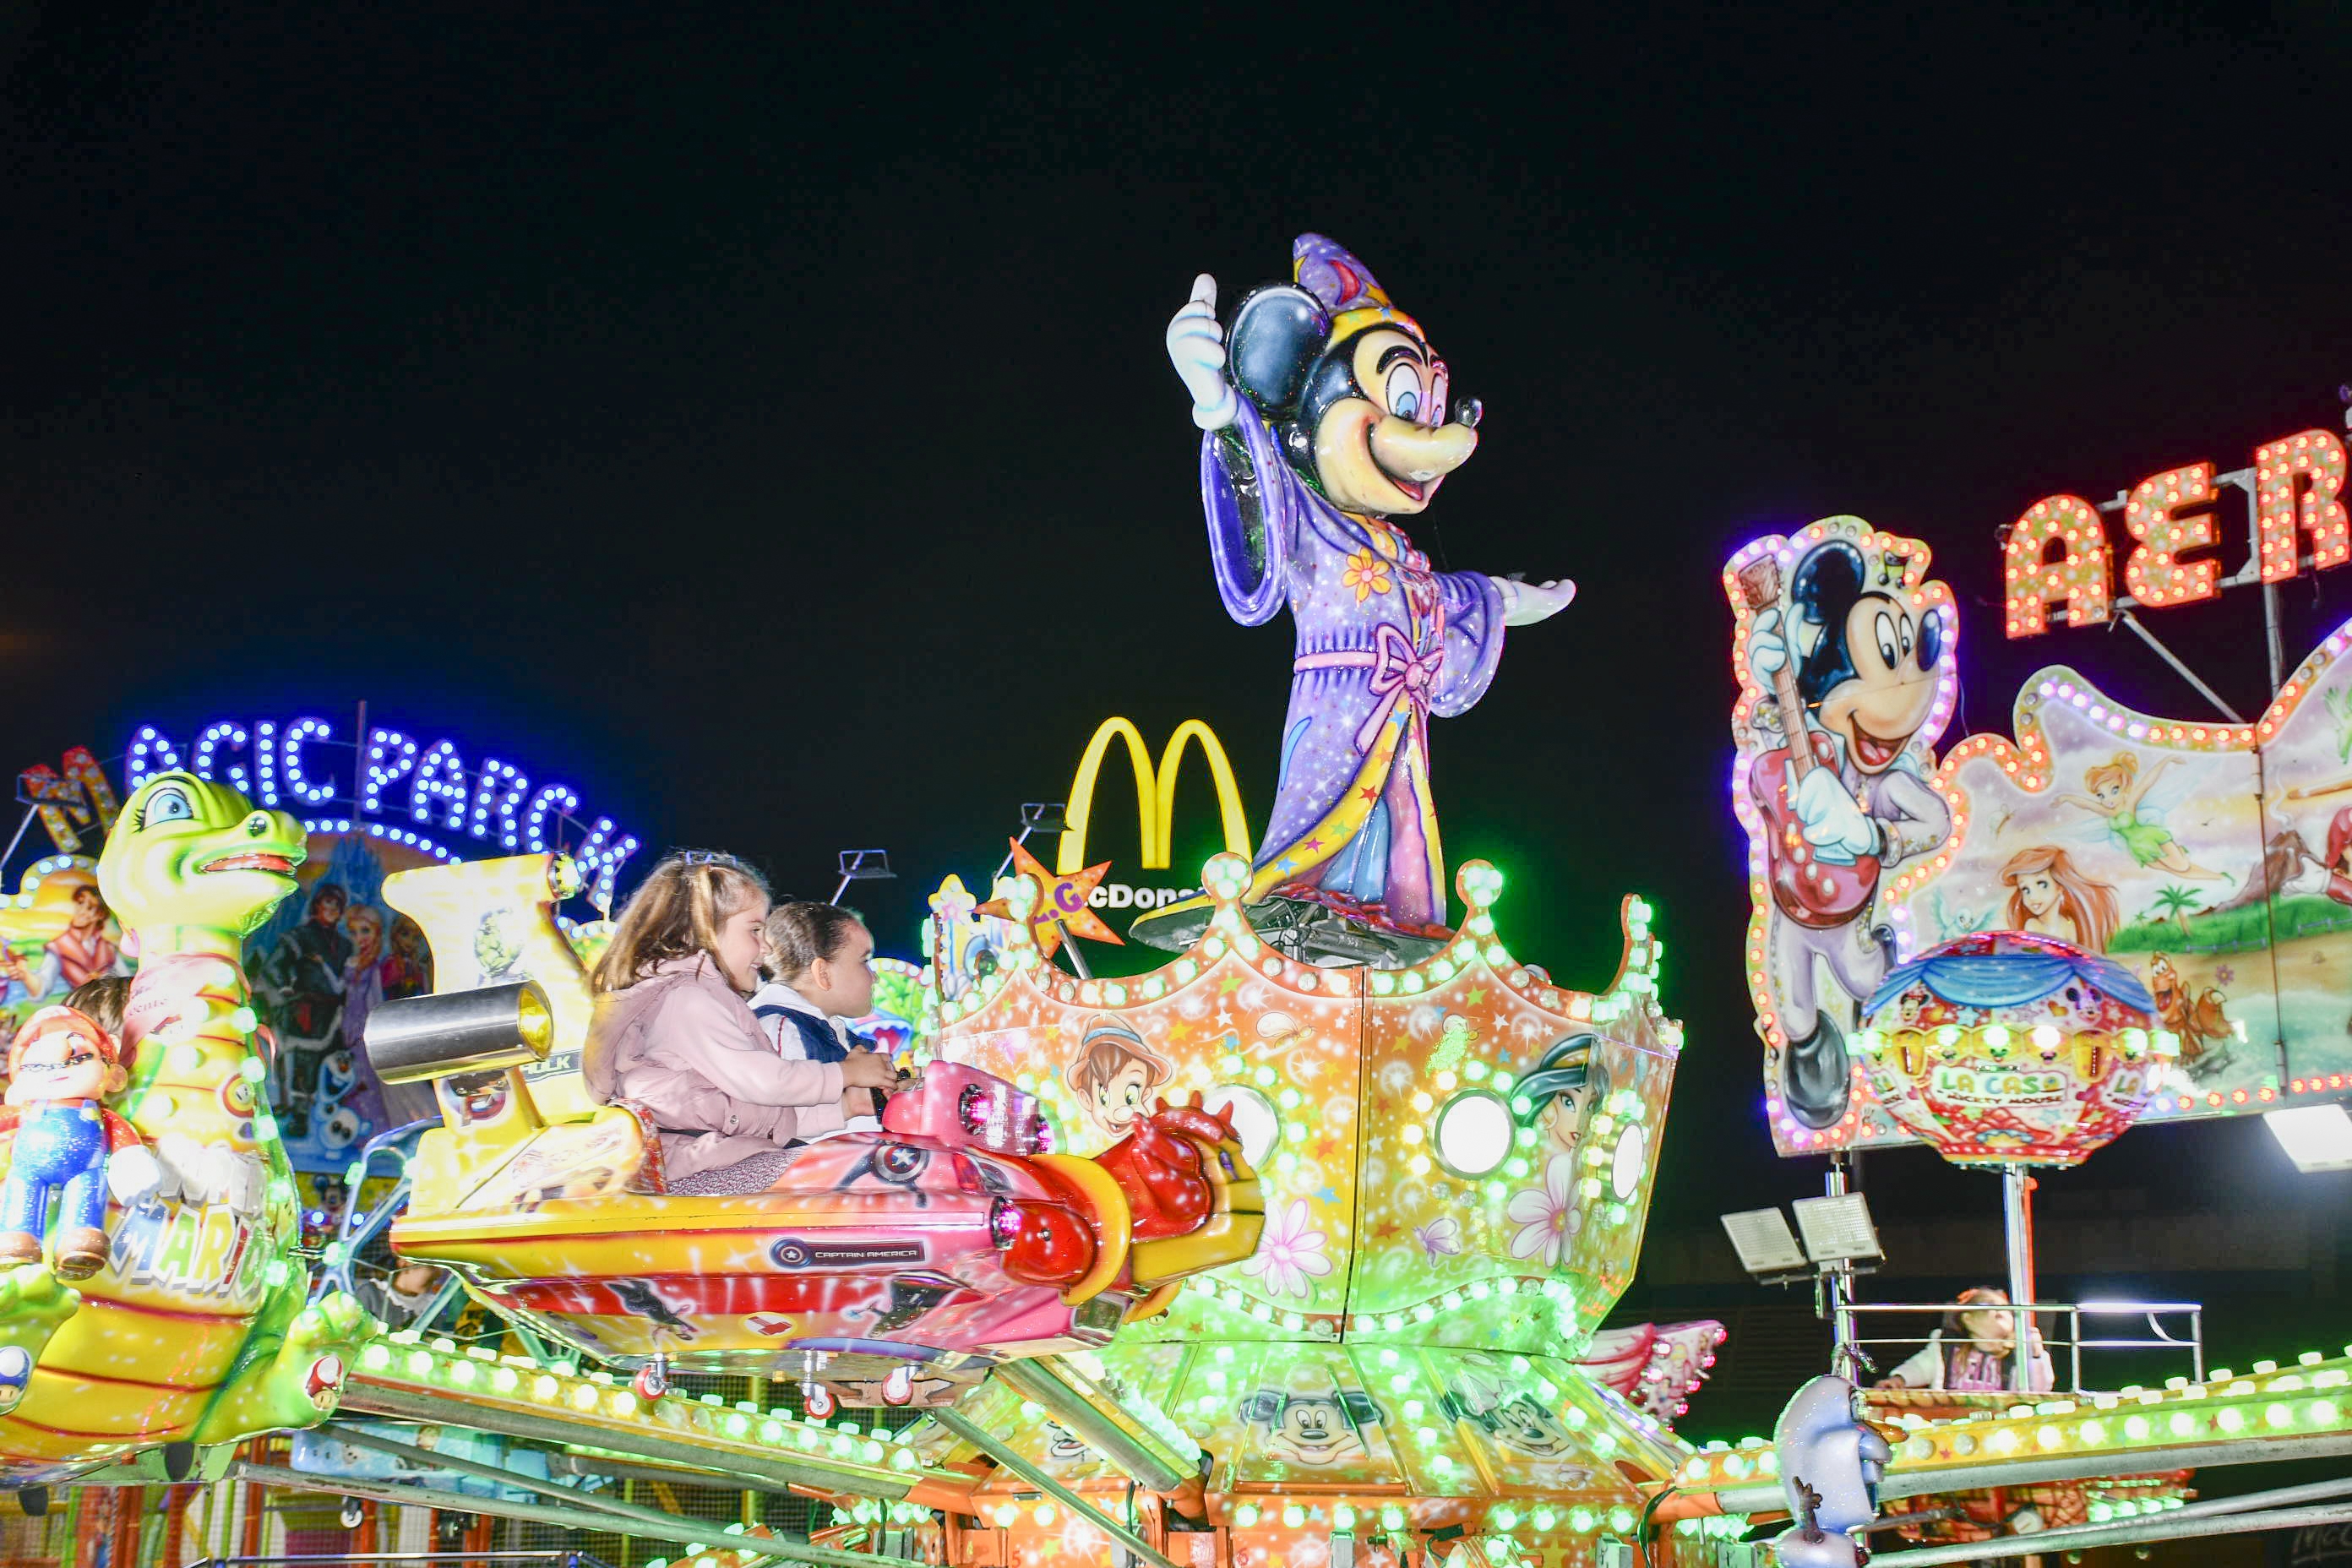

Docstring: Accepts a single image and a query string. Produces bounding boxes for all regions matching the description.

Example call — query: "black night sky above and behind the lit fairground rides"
[0,5,2352,1260]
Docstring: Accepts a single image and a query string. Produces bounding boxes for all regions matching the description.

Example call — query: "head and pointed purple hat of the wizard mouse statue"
[1230,235,1479,517]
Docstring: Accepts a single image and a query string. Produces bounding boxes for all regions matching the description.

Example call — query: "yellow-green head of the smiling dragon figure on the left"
[99,773,306,935]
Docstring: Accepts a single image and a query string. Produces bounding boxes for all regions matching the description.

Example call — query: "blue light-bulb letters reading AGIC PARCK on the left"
[122,719,637,907]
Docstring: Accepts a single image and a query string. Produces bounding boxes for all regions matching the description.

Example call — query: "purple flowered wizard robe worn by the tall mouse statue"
[1200,397,1503,926]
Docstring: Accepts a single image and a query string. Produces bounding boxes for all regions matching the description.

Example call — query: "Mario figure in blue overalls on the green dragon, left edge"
[0,1006,162,1279]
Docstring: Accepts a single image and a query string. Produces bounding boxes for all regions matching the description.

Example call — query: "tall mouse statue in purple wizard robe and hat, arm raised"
[1131,235,1576,964]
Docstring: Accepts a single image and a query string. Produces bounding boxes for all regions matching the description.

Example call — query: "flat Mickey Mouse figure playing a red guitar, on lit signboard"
[1740,536,1952,1129]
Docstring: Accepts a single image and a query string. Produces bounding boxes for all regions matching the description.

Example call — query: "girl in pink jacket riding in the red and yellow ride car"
[583,851,896,1195]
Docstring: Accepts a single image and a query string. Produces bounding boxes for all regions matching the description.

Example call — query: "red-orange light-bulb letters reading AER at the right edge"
[2001,430,2352,637]
